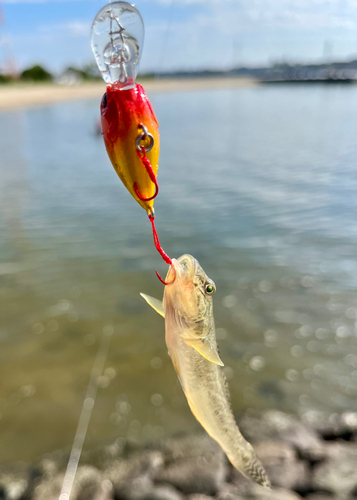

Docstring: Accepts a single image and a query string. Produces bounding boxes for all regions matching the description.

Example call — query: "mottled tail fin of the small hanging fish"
[228,442,270,488]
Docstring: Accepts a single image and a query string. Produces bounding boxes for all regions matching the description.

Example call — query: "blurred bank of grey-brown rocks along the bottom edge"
[0,411,357,500]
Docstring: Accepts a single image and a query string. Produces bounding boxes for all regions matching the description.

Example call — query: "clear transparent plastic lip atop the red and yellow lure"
[91,2,144,90]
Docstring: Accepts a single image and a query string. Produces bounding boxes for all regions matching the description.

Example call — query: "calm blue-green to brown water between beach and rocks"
[0,86,357,462]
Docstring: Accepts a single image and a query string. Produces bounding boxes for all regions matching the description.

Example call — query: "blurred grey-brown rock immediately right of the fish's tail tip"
[255,441,311,492]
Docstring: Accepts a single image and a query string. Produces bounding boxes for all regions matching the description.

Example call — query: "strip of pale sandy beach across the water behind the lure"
[0,78,257,112]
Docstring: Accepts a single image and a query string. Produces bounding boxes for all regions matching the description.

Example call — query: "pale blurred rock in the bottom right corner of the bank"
[312,442,357,497]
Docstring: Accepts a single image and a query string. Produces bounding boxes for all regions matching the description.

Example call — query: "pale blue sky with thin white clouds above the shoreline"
[0,0,357,73]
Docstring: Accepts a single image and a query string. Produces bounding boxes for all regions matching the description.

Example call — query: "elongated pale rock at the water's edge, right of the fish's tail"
[239,410,325,462]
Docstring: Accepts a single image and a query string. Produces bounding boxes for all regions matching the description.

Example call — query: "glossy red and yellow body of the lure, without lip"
[101,83,160,213]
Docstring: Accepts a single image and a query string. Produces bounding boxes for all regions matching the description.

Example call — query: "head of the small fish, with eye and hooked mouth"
[164,254,216,330]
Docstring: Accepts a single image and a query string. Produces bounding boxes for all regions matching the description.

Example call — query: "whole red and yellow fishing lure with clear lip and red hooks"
[91,2,172,284]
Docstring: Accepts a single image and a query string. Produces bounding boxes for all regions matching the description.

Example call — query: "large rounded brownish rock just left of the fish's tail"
[155,434,228,495]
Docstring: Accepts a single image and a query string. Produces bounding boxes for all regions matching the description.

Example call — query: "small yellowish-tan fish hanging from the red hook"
[141,255,270,487]
